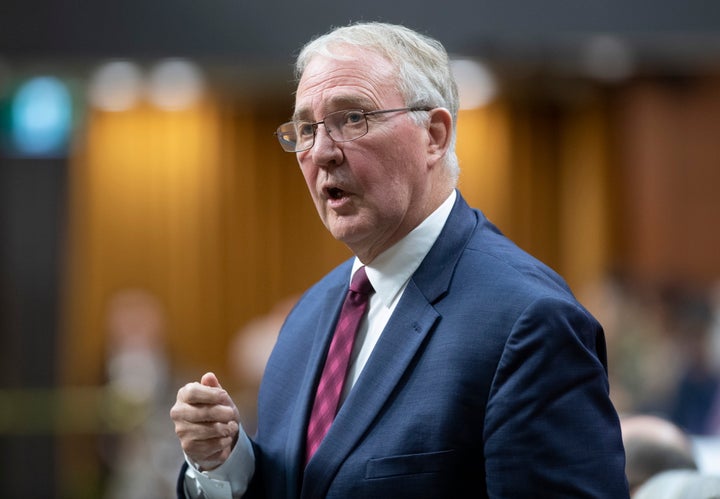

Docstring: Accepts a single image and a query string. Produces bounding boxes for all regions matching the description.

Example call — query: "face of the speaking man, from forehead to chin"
[295,48,430,263]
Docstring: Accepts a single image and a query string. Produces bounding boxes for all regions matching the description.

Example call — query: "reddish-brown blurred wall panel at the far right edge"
[615,78,720,289]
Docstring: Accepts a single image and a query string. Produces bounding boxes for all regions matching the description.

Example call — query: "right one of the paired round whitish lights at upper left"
[147,59,203,110]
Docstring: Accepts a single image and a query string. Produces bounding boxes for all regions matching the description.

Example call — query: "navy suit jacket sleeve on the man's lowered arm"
[484,298,627,497]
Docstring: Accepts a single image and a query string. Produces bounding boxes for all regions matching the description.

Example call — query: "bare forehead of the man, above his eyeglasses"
[295,47,404,119]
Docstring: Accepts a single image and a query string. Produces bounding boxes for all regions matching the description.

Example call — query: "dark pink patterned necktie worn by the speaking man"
[305,267,374,462]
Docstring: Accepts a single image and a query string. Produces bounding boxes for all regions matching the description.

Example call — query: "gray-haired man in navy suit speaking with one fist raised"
[171,23,628,499]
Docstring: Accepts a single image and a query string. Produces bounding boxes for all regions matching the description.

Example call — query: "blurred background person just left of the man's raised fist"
[102,288,182,499]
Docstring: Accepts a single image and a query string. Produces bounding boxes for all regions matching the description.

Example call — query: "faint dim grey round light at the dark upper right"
[582,35,635,81]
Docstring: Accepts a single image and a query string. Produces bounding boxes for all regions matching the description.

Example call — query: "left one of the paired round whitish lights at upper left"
[88,61,143,111]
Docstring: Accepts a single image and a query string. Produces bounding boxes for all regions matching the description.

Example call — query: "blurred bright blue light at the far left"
[10,76,72,156]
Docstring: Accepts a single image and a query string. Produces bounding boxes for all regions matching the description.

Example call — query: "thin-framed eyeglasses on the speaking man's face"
[275,107,433,152]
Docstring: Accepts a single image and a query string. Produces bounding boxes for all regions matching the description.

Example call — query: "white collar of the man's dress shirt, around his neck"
[352,189,457,307]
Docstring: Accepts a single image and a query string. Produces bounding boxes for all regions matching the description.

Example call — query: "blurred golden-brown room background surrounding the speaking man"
[0,0,720,499]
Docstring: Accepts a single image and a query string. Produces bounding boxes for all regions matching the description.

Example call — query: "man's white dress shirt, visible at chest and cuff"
[185,189,457,499]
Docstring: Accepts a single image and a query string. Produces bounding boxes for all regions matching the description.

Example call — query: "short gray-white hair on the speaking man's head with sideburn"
[295,22,459,180]
